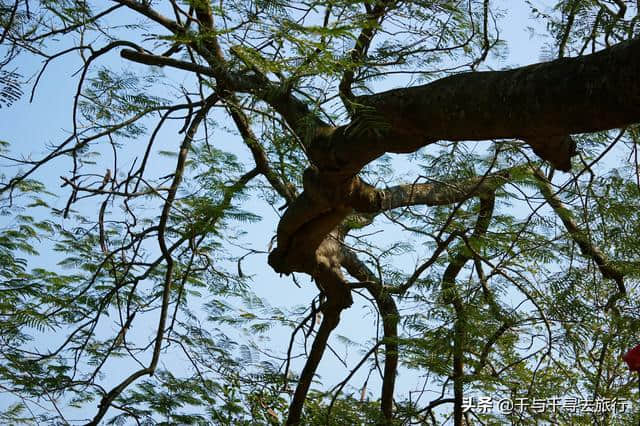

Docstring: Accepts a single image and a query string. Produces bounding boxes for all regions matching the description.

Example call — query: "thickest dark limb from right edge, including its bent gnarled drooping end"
[269,40,640,300]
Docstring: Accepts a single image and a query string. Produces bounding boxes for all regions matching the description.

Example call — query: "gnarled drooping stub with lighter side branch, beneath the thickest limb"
[269,168,511,273]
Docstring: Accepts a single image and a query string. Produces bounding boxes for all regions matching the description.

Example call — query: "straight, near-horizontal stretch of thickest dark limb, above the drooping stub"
[310,39,640,173]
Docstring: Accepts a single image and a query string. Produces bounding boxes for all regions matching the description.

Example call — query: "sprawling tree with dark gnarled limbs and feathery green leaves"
[0,0,640,425]
